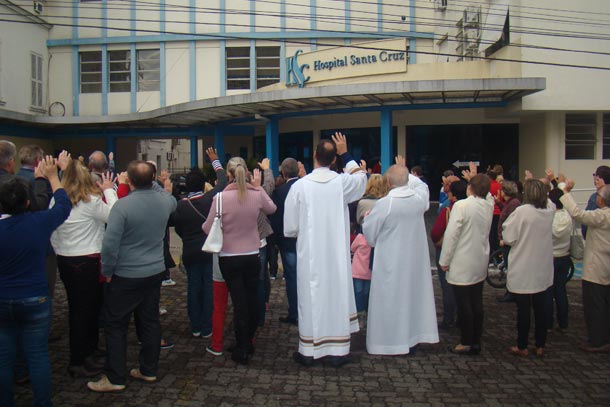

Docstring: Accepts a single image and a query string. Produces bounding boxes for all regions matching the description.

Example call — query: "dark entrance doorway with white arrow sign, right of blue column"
[407,124,519,200]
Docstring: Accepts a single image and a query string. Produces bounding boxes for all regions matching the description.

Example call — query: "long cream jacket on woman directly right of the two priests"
[439,194,495,285]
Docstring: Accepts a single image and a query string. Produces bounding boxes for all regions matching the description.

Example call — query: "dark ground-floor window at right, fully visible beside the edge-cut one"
[565,113,597,160]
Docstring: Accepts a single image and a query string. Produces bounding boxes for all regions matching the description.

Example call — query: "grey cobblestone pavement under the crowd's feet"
[16,206,610,407]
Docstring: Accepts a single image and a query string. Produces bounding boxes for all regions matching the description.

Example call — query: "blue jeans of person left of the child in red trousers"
[185,257,214,335]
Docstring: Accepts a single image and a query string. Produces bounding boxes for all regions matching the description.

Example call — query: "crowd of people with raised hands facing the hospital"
[0,138,610,406]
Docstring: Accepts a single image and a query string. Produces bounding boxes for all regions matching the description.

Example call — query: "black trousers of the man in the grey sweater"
[105,272,163,384]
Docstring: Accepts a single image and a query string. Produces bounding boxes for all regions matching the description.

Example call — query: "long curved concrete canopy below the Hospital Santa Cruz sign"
[0,78,546,130]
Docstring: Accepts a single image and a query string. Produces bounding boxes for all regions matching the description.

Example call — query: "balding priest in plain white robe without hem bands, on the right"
[362,161,438,355]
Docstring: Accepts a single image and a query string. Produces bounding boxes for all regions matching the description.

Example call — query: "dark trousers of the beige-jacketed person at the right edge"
[582,280,610,348]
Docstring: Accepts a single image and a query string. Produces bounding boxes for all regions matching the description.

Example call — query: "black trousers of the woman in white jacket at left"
[57,256,102,365]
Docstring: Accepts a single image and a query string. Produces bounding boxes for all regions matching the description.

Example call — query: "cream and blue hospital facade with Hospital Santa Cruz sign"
[0,0,610,202]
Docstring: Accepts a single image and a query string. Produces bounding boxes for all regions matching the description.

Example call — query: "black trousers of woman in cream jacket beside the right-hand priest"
[453,281,484,346]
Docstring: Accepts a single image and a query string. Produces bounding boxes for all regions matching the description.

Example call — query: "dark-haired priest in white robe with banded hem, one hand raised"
[284,133,366,366]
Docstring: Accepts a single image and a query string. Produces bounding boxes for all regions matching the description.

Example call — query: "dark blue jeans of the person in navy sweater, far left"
[0,297,53,407]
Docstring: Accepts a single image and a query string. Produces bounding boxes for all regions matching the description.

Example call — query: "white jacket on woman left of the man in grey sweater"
[51,188,118,257]
